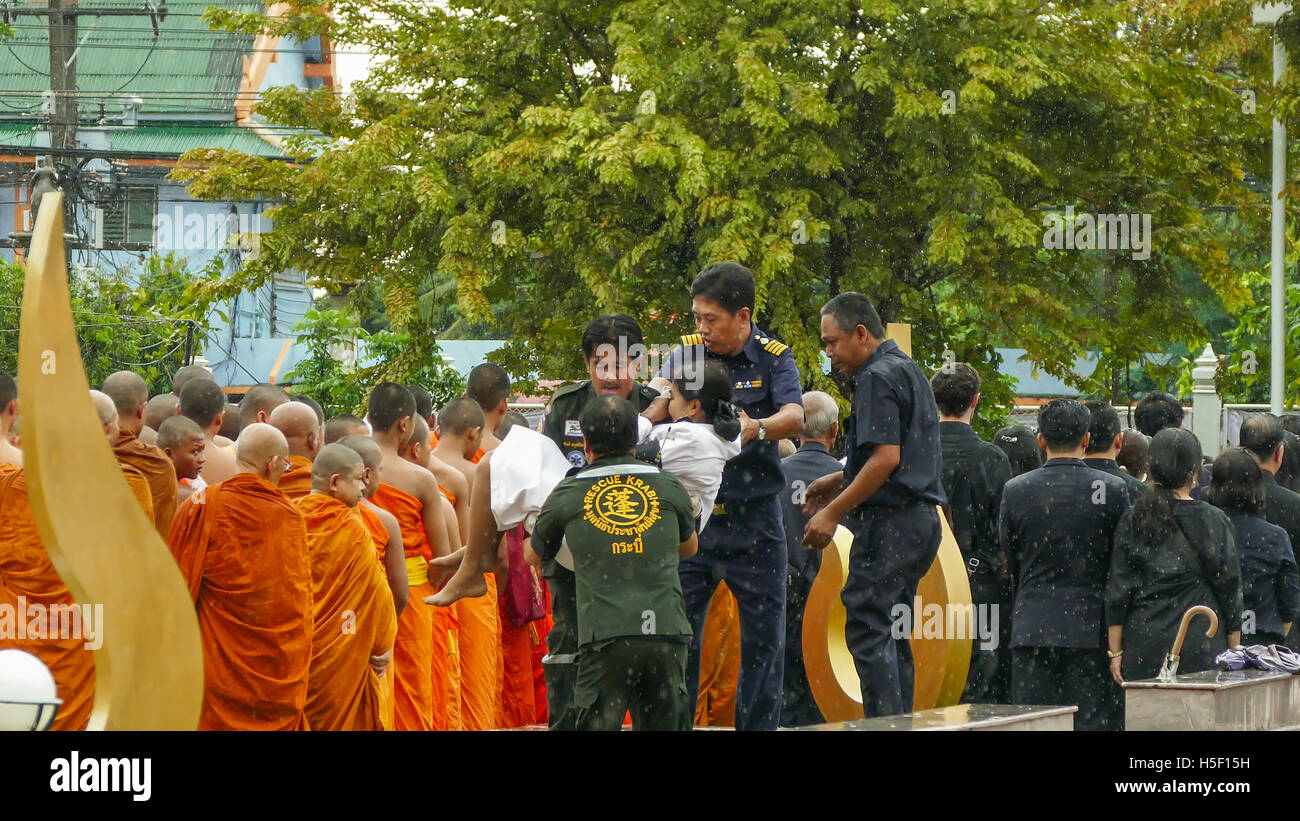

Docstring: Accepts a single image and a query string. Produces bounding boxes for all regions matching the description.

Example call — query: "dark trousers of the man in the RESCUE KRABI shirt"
[573,638,693,730]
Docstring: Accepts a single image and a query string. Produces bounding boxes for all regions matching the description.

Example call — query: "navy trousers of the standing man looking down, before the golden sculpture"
[840,504,943,718]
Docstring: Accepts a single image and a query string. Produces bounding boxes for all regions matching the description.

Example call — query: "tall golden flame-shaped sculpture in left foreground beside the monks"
[18,194,203,730]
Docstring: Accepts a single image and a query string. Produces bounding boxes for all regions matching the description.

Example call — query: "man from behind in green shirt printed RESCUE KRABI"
[533,396,697,730]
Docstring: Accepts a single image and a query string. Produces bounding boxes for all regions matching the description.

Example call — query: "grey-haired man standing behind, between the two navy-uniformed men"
[781,391,841,727]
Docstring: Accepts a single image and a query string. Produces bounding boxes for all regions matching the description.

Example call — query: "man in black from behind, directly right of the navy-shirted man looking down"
[930,362,1011,704]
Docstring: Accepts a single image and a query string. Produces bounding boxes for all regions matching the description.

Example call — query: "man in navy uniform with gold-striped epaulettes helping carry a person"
[646,262,803,730]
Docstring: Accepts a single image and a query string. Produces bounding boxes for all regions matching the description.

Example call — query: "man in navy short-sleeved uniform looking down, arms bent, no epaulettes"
[803,292,948,718]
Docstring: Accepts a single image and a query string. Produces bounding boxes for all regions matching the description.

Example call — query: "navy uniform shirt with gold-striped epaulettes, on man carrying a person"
[659,322,803,504]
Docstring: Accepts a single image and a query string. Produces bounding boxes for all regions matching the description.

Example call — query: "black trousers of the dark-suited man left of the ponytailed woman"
[1011,647,1125,730]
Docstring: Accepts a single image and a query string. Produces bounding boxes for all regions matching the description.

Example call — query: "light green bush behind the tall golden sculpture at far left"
[0,253,212,394]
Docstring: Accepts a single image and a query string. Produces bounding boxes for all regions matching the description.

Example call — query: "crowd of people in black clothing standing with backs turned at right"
[931,374,1300,729]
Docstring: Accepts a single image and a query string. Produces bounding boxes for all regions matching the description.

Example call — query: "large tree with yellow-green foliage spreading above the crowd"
[174,0,1269,426]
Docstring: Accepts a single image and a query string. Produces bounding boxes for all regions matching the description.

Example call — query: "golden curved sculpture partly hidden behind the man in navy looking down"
[803,322,975,721]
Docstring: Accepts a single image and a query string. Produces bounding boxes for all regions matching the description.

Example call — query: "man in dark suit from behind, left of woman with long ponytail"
[998,399,1130,730]
